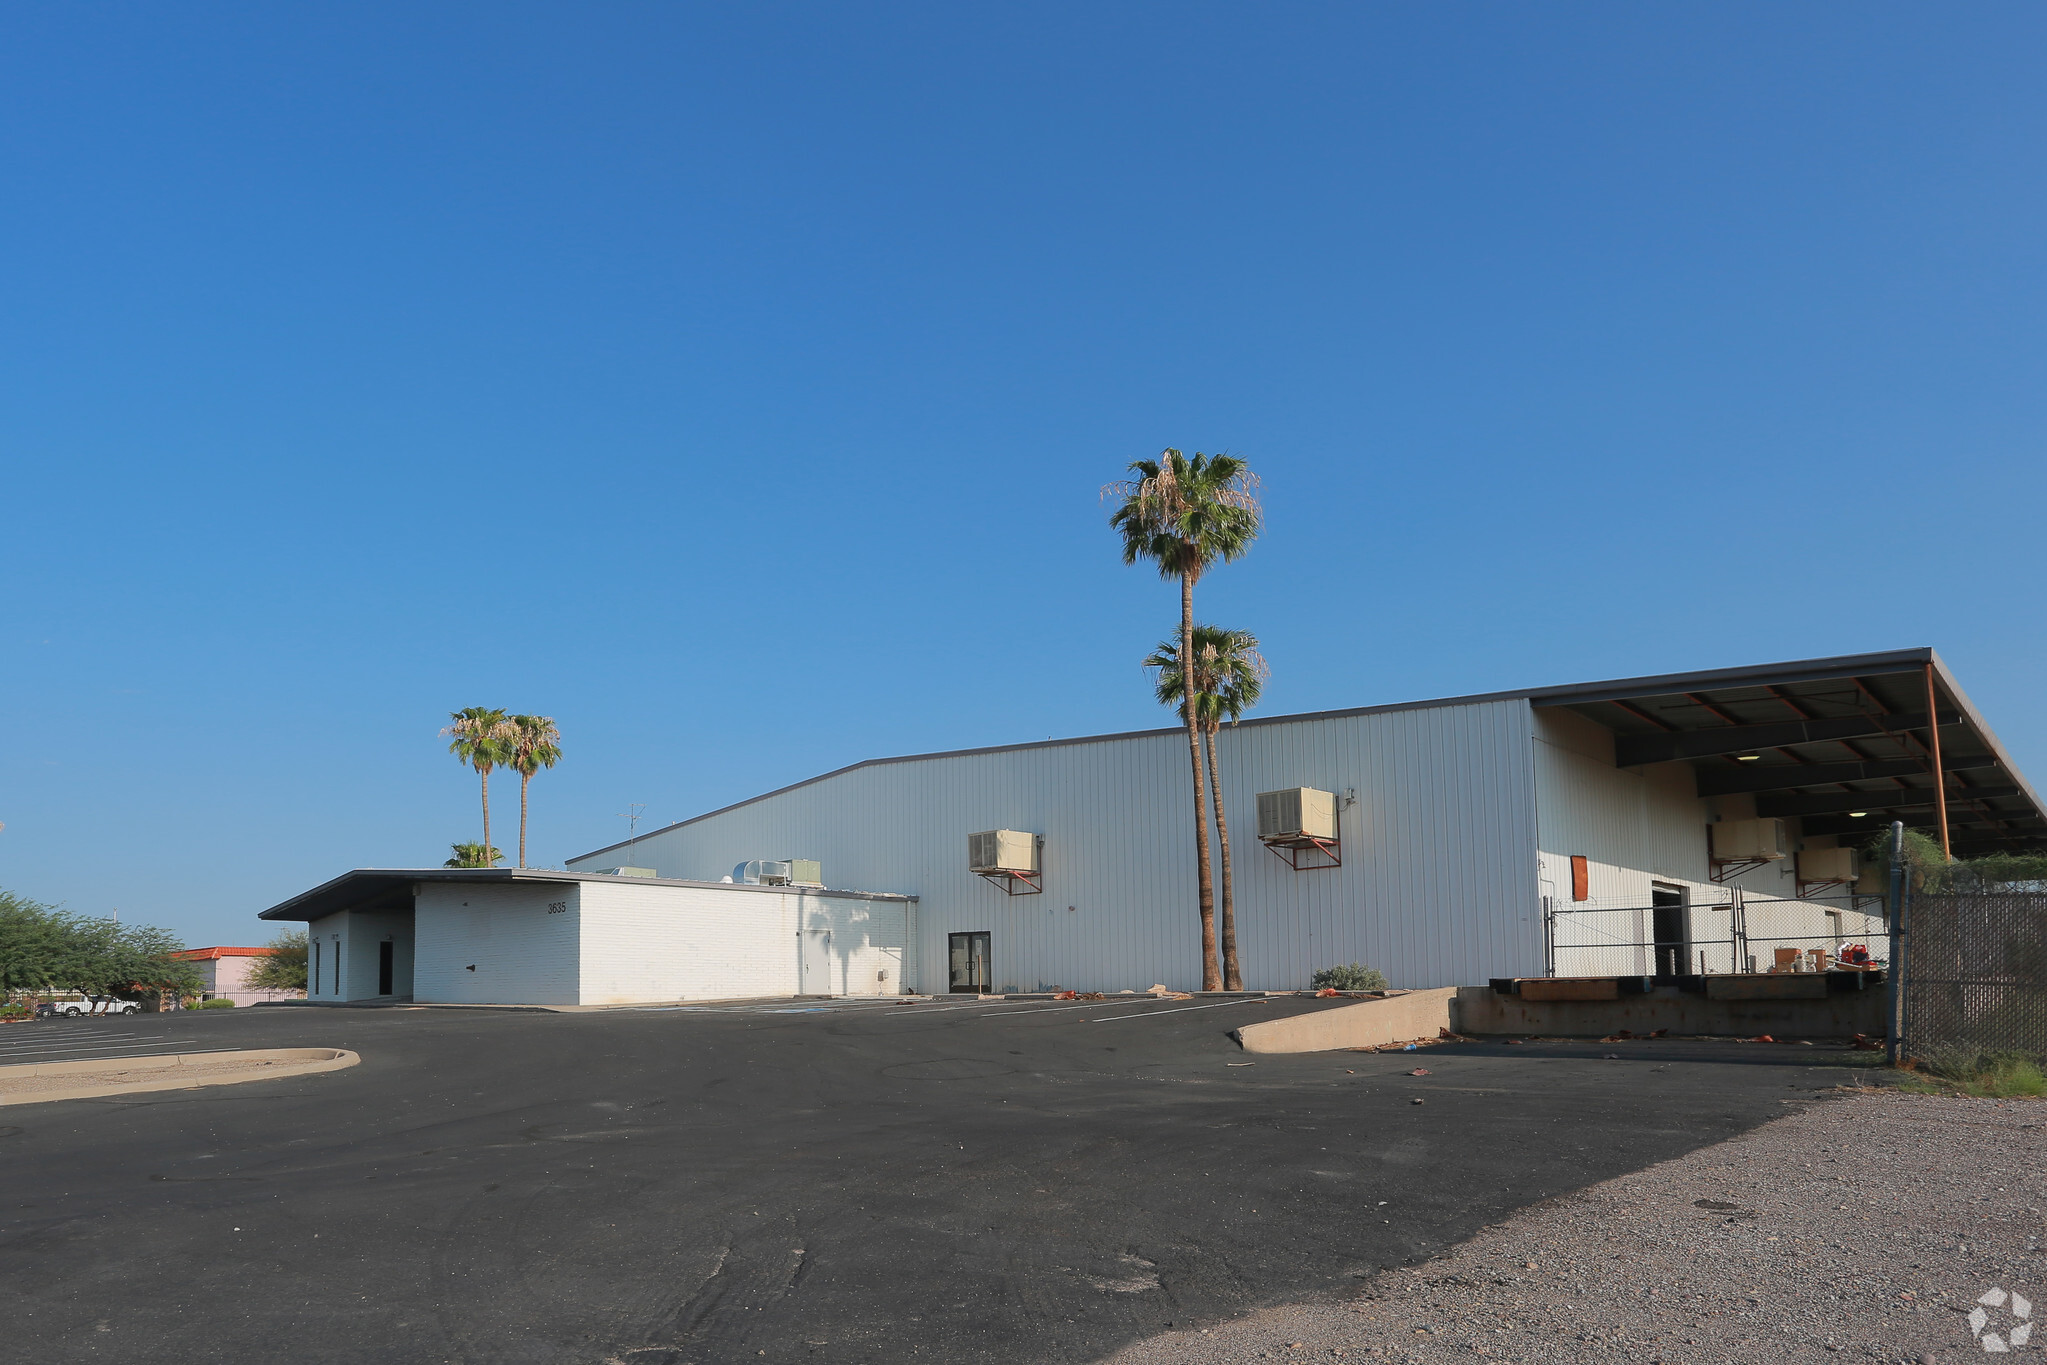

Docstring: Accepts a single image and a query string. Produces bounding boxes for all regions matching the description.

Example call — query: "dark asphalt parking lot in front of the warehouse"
[0,999,1853,1365]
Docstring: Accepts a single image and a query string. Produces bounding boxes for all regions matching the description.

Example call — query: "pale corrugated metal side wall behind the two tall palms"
[571,700,1541,990]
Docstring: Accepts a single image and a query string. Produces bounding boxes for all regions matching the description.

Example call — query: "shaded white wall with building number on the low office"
[413,882,581,1005]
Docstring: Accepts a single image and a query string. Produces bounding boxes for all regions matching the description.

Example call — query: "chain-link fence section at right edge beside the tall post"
[1902,890,2047,1058]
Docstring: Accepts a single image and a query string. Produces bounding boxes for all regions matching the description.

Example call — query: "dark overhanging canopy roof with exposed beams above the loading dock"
[1527,649,2047,857]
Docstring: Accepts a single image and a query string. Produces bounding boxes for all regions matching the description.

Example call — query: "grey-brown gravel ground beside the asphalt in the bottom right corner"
[1109,1091,2047,1365]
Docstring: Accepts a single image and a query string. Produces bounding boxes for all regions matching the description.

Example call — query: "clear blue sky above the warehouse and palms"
[0,2,2047,943]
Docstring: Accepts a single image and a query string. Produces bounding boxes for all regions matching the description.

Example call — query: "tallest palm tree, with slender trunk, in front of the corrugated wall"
[1101,450,1259,990]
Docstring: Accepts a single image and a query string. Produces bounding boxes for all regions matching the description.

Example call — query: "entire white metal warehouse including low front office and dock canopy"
[264,649,2047,1003]
